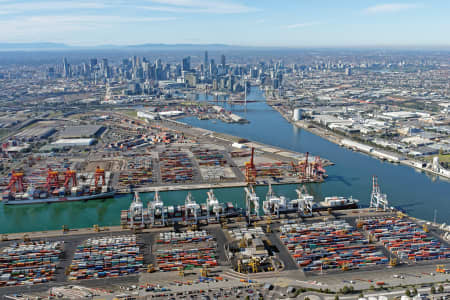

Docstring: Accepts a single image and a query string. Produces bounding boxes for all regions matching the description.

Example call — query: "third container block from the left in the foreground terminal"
[156,230,217,272]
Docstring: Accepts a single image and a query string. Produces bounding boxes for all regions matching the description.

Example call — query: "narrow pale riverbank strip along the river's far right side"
[272,106,450,179]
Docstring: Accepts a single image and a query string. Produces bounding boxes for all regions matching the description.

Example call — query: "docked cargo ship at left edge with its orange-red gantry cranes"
[2,168,115,205]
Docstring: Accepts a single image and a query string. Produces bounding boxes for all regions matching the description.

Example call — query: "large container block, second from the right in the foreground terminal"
[280,220,388,271]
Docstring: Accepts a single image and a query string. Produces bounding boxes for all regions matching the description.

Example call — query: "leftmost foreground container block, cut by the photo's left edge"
[0,241,63,286]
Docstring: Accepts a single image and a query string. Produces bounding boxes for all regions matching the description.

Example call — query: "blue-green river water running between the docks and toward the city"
[0,88,450,233]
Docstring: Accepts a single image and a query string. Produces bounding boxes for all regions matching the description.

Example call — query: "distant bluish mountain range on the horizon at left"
[0,42,242,51]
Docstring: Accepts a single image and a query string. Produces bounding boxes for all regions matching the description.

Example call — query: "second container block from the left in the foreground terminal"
[69,235,144,280]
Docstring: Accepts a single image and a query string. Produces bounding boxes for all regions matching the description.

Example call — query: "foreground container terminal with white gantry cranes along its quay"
[0,178,450,297]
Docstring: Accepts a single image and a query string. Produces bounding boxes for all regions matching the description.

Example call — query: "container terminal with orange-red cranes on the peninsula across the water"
[0,111,332,204]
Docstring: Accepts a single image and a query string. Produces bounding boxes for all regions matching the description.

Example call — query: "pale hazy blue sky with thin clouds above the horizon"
[0,0,450,47]
